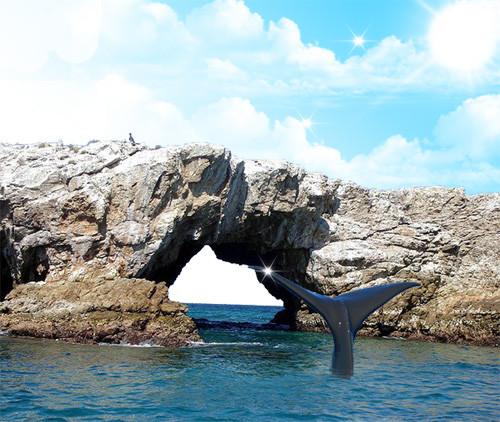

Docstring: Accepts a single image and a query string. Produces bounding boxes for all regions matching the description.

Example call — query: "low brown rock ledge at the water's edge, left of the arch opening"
[0,278,201,347]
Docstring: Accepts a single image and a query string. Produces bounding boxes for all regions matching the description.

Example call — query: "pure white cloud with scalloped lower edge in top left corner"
[0,0,101,72]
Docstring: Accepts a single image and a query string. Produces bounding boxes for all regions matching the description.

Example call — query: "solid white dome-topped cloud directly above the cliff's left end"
[0,75,195,145]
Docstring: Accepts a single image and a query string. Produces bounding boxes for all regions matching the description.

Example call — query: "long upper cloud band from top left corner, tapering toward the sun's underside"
[0,0,499,95]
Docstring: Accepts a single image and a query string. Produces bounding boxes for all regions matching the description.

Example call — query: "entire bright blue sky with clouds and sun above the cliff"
[0,0,500,194]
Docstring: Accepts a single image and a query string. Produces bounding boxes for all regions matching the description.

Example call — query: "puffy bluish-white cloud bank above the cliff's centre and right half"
[191,96,500,193]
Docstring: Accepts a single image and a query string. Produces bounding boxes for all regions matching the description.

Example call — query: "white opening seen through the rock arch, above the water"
[169,246,283,306]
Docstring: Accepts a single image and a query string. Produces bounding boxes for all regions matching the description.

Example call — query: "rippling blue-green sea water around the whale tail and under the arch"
[0,305,500,421]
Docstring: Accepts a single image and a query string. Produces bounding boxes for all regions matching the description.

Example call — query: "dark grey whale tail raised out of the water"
[249,266,420,378]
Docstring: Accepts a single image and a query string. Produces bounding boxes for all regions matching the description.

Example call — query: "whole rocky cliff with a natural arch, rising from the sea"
[0,142,500,345]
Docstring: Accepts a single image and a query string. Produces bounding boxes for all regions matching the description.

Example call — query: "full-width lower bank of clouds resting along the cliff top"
[0,64,500,192]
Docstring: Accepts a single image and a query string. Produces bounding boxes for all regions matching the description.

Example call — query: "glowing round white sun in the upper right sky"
[428,1,498,72]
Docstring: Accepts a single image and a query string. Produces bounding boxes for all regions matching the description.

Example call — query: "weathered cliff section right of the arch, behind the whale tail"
[290,181,500,345]
